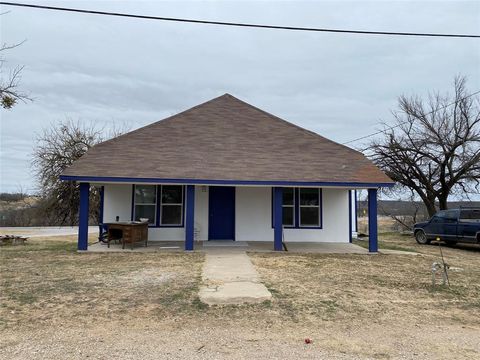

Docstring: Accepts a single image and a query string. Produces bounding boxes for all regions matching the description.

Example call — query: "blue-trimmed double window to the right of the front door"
[272,187,322,228]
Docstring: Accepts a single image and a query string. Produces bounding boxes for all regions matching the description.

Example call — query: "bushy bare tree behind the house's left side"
[33,120,125,225]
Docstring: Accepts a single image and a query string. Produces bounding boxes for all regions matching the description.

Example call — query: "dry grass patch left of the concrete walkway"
[0,237,203,327]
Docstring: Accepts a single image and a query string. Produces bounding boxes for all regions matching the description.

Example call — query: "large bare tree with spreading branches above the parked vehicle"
[367,76,480,216]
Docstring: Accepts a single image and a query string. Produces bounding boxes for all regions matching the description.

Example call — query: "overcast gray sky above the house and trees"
[0,0,480,192]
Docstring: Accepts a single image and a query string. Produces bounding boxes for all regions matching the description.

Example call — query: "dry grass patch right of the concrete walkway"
[252,244,480,324]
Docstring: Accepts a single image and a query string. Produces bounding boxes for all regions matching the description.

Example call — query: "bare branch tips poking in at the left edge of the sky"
[0,40,32,109]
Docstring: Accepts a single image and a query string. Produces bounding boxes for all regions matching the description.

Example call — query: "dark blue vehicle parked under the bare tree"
[413,208,480,245]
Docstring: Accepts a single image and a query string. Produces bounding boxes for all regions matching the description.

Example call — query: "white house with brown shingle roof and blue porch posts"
[61,94,393,252]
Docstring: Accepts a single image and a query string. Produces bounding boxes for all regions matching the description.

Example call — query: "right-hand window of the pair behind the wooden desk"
[160,185,183,225]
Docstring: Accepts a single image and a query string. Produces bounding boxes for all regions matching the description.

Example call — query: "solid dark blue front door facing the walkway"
[208,186,235,240]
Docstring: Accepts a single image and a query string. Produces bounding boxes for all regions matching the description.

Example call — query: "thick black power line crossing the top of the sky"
[0,1,480,38]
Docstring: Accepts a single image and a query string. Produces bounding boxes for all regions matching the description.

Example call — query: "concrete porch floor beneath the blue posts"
[82,241,368,254]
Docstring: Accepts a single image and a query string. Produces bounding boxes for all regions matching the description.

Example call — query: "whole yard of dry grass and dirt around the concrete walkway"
[0,234,480,359]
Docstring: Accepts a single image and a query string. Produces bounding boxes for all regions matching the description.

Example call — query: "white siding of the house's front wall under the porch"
[104,184,353,242]
